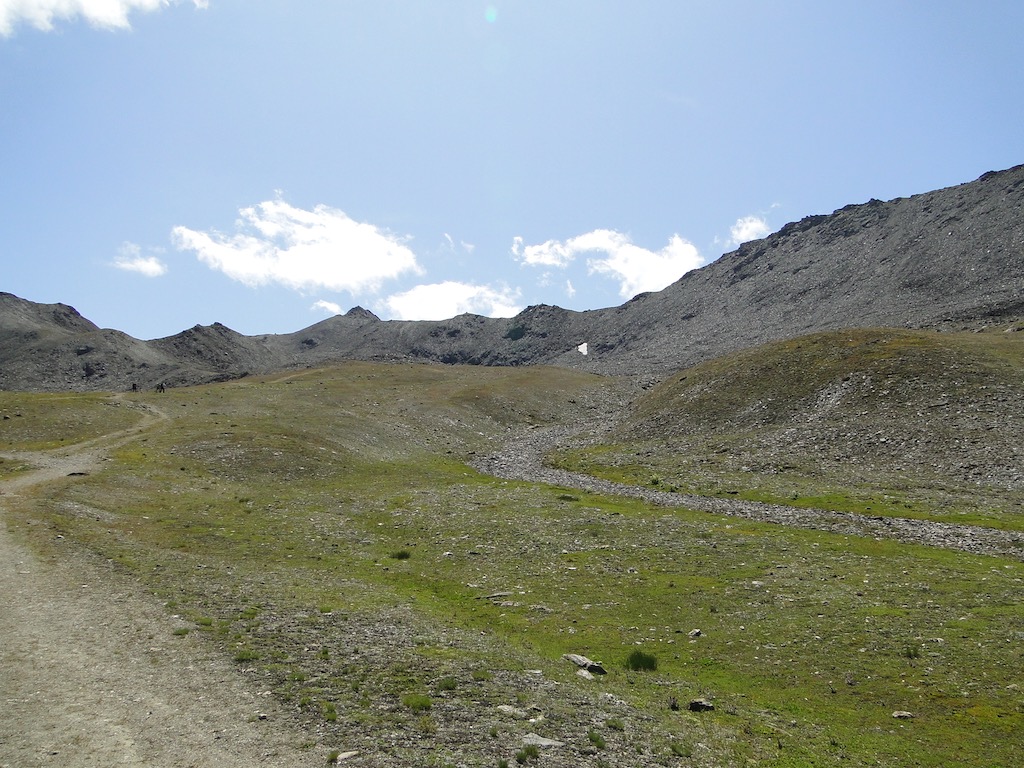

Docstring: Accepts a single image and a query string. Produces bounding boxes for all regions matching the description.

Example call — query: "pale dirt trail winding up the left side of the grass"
[0,409,326,768]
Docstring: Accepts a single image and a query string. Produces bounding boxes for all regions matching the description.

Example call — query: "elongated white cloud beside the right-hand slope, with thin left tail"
[512,229,705,298]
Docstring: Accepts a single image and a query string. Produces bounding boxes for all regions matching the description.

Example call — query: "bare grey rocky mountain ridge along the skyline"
[0,165,1024,390]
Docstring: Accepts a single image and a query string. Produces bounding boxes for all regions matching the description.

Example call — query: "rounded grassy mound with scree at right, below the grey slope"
[556,330,1024,530]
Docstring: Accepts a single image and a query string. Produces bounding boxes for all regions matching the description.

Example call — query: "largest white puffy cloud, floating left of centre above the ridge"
[171,200,423,293]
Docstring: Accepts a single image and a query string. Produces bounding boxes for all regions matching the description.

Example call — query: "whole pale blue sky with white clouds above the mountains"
[0,0,1024,339]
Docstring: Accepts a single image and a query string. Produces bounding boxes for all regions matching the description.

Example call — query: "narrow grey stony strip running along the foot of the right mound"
[475,427,1024,560]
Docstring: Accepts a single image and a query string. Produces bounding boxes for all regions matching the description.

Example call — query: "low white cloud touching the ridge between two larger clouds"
[382,281,522,321]
